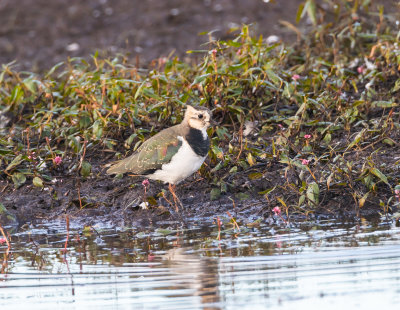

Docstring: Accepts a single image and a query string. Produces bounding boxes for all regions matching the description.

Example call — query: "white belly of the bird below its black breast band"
[149,137,207,184]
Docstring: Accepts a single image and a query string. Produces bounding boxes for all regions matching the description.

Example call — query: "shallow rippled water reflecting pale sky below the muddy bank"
[0,219,400,310]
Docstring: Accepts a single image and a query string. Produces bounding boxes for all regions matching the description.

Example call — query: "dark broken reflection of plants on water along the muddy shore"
[0,217,397,273]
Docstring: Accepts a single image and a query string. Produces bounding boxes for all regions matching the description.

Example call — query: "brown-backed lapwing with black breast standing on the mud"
[107,105,212,211]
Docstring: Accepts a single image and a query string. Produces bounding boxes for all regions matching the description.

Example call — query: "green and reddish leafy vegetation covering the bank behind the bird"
[0,0,400,218]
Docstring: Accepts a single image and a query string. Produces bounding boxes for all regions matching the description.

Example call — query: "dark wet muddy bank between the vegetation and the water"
[0,151,390,227]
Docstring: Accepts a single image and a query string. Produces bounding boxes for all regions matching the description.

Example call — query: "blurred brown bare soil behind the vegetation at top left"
[0,0,308,71]
